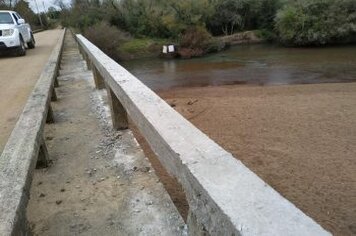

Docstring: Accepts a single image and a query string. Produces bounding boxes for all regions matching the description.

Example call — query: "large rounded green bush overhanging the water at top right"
[276,0,356,46]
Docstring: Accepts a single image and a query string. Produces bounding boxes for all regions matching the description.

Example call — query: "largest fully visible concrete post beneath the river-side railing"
[106,85,129,130]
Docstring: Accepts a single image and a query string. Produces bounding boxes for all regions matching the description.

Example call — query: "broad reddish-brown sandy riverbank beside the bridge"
[154,83,356,235]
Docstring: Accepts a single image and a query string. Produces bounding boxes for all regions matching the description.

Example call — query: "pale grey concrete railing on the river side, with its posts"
[76,35,330,236]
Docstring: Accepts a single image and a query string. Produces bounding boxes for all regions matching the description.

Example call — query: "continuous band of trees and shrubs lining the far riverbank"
[61,0,356,59]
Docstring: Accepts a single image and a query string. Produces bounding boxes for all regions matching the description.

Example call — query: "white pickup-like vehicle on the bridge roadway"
[0,11,36,56]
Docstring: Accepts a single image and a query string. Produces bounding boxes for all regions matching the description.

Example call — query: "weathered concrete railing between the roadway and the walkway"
[0,30,65,236]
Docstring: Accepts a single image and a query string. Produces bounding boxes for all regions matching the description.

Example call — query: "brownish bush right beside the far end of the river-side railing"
[84,22,130,60]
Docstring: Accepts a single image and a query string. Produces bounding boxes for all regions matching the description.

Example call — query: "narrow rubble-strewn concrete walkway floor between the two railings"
[28,30,184,236]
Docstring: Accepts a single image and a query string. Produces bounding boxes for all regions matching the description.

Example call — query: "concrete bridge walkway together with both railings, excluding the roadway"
[0,28,329,235]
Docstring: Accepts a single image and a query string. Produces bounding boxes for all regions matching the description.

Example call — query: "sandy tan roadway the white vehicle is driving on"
[0,30,62,153]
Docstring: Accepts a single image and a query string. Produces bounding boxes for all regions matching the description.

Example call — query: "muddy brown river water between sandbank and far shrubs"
[122,44,356,90]
